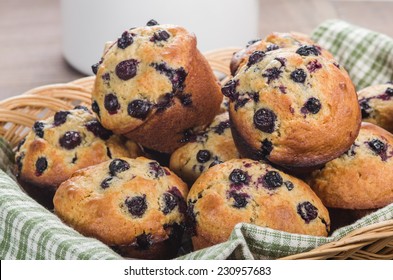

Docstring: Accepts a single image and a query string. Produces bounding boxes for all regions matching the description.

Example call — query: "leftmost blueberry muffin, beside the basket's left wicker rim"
[15,107,138,207]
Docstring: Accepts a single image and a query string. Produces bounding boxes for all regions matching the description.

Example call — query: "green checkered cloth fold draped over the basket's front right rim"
[178,203,393,260]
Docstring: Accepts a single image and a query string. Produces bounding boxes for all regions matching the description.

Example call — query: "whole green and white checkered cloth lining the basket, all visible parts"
[0,20,393,260]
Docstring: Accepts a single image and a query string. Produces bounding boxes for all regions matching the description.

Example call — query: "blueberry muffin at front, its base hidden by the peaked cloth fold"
[187,159,330,249]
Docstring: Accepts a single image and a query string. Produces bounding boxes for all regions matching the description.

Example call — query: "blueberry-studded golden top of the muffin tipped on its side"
[92,25,196,133]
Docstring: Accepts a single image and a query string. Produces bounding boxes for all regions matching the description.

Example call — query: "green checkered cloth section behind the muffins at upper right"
[311,20,393,90]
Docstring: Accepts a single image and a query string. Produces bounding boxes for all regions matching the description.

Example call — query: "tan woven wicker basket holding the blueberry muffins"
[0,48,393,260]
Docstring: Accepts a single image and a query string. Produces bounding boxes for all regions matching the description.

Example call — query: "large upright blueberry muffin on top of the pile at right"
[222,46,361,172]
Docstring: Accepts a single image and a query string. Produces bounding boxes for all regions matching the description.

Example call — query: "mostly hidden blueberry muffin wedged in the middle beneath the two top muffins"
[169,113,239,185]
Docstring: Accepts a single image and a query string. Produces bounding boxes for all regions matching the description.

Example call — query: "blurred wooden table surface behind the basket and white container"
[0,0,393,100]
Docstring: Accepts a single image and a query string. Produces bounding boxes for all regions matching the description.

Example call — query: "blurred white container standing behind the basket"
[61,0,259,75]
